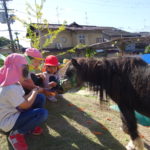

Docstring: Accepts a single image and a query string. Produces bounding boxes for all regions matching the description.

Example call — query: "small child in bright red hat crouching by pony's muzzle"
[42,55,62,102]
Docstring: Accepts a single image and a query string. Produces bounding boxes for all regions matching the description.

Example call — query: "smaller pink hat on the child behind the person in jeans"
[25,48,44,60]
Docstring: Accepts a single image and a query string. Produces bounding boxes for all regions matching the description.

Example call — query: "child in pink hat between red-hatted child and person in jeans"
[22,48,44,94]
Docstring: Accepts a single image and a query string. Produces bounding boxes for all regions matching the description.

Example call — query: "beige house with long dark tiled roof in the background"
[30,22,146,56]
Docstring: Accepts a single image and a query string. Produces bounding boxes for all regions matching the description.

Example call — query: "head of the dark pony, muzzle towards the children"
[59,59,83,92]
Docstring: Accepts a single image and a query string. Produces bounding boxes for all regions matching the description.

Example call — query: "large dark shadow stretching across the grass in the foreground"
[4,95,125,150]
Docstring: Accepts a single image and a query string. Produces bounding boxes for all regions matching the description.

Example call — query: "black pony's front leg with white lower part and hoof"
[119,106,144,150]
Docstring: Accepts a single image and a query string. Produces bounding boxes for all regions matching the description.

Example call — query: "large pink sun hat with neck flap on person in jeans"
[0,53,27,86]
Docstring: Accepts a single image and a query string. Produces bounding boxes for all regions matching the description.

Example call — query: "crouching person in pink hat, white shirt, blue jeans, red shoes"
[0,53,48,150]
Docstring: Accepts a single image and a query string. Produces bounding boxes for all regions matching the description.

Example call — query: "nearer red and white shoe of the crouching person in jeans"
[8,132,28,150]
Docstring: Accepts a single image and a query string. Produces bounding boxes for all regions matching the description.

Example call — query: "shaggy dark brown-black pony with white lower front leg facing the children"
[60,57,150,150]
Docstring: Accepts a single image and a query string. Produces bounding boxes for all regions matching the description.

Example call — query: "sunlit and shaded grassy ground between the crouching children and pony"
[0,94,149,150]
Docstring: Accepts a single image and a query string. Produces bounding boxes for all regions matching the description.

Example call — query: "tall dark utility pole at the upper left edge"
[2,0,15,52]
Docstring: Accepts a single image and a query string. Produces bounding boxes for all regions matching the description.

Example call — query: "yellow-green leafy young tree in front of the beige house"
[16,0,66,49]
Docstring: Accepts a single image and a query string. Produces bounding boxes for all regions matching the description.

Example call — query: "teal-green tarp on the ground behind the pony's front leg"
[110,105,150,126]
